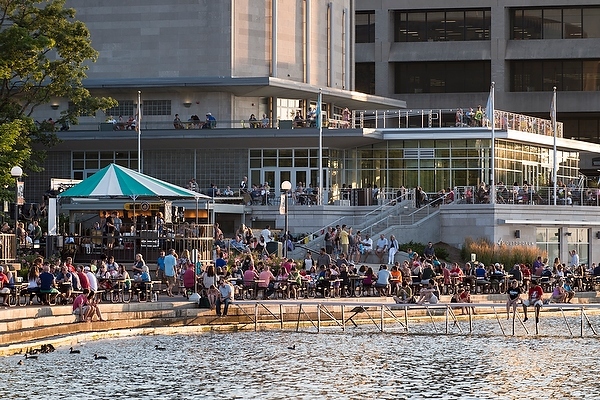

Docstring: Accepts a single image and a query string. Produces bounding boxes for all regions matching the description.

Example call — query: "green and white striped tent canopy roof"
[59,164,210,200]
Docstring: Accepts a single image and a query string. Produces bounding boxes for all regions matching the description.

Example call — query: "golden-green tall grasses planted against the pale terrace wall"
[461,238,548,269]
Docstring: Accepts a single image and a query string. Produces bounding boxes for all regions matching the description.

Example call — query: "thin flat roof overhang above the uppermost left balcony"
[84,76,406,110]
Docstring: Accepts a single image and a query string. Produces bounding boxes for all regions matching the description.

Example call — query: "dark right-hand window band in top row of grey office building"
[510,6,600,40]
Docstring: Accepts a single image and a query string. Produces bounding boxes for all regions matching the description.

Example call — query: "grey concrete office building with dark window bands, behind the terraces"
[355,0,600,178]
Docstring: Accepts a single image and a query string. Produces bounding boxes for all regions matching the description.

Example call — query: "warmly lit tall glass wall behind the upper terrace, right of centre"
[329,139,579,192]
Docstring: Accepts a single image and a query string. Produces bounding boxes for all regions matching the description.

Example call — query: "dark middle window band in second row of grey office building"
[394,61,491,94]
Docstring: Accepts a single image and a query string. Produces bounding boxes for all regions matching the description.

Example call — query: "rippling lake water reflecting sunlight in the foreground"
[0,319,600,399]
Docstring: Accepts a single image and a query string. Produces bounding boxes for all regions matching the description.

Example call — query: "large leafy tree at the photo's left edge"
[0,0,117,198]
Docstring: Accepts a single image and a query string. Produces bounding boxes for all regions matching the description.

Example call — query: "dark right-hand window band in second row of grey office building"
[510,59,600,92]
